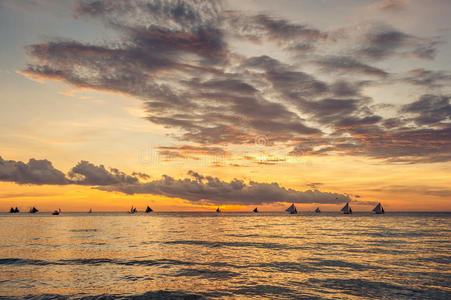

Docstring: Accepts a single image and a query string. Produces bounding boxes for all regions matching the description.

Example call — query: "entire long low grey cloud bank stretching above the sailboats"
[0,157,352,205]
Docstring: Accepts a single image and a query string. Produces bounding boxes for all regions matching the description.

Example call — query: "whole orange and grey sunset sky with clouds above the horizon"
[0,0,451,211]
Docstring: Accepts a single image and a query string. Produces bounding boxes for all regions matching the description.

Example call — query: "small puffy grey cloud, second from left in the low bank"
[68,160,139,185]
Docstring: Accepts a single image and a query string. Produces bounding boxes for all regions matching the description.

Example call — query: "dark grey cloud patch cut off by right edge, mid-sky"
[401,94,451,125]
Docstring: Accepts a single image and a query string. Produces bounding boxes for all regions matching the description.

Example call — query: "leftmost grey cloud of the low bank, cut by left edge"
[0,157,69,185]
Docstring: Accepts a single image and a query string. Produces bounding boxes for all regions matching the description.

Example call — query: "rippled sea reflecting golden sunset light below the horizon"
[0,213,451,299]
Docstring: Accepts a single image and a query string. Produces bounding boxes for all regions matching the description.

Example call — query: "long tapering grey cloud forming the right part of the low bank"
[99,171,351,205]
